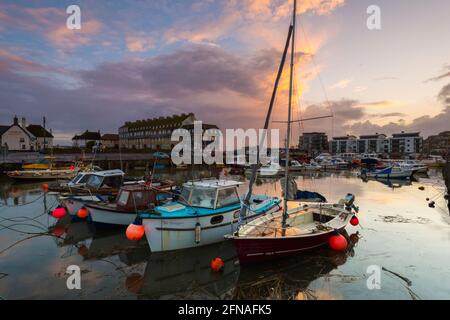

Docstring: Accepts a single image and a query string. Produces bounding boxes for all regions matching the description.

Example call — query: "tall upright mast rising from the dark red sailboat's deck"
[283,0,297,229]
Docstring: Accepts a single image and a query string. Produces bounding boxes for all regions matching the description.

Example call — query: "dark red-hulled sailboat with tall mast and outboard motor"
[226,0,358,264]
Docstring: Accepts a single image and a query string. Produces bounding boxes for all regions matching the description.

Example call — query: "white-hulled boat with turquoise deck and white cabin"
[139,180,281,252]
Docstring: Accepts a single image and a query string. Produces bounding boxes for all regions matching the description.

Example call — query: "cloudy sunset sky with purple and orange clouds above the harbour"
[0,0,450,144]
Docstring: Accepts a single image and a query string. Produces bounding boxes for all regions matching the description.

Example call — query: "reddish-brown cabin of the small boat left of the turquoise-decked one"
[116,185,158,211]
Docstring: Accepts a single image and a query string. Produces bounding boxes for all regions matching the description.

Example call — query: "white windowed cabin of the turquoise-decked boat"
[178,180,242,209]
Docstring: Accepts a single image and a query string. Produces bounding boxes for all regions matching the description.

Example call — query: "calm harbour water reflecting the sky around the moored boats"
[0,170,450,299]
